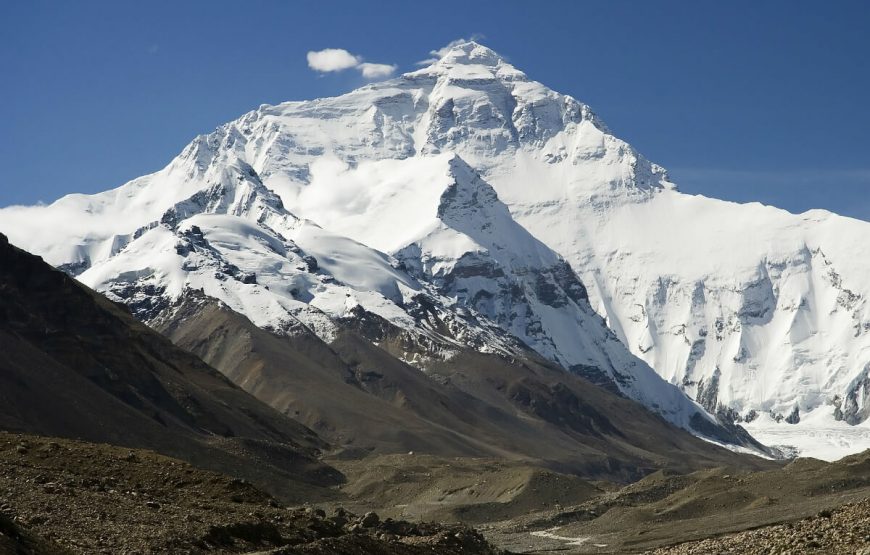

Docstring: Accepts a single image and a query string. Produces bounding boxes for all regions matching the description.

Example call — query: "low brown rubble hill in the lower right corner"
[488,451,870,553]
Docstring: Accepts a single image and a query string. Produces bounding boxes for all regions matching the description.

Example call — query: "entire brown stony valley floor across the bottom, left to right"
[0,432,870,555]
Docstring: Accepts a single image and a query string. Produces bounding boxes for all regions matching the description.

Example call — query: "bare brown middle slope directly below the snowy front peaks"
[159,298,773,481]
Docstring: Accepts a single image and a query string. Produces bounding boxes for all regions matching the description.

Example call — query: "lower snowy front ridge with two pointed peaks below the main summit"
[1,143,724,441]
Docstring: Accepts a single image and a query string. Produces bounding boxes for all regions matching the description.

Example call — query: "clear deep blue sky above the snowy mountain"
[0,0,870,219]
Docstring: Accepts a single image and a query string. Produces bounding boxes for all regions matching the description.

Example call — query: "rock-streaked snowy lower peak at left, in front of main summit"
[71,155,519,364]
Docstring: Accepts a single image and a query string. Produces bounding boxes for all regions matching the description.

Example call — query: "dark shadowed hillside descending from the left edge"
[0,235,342,499]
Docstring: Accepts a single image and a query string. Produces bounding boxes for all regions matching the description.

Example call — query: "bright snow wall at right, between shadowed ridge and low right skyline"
[521,191,870,423]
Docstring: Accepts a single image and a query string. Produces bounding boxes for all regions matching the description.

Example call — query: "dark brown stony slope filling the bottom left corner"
[0,432,501,555]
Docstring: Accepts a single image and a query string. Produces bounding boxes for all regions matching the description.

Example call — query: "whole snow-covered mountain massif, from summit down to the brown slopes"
[0,38,870,456]
